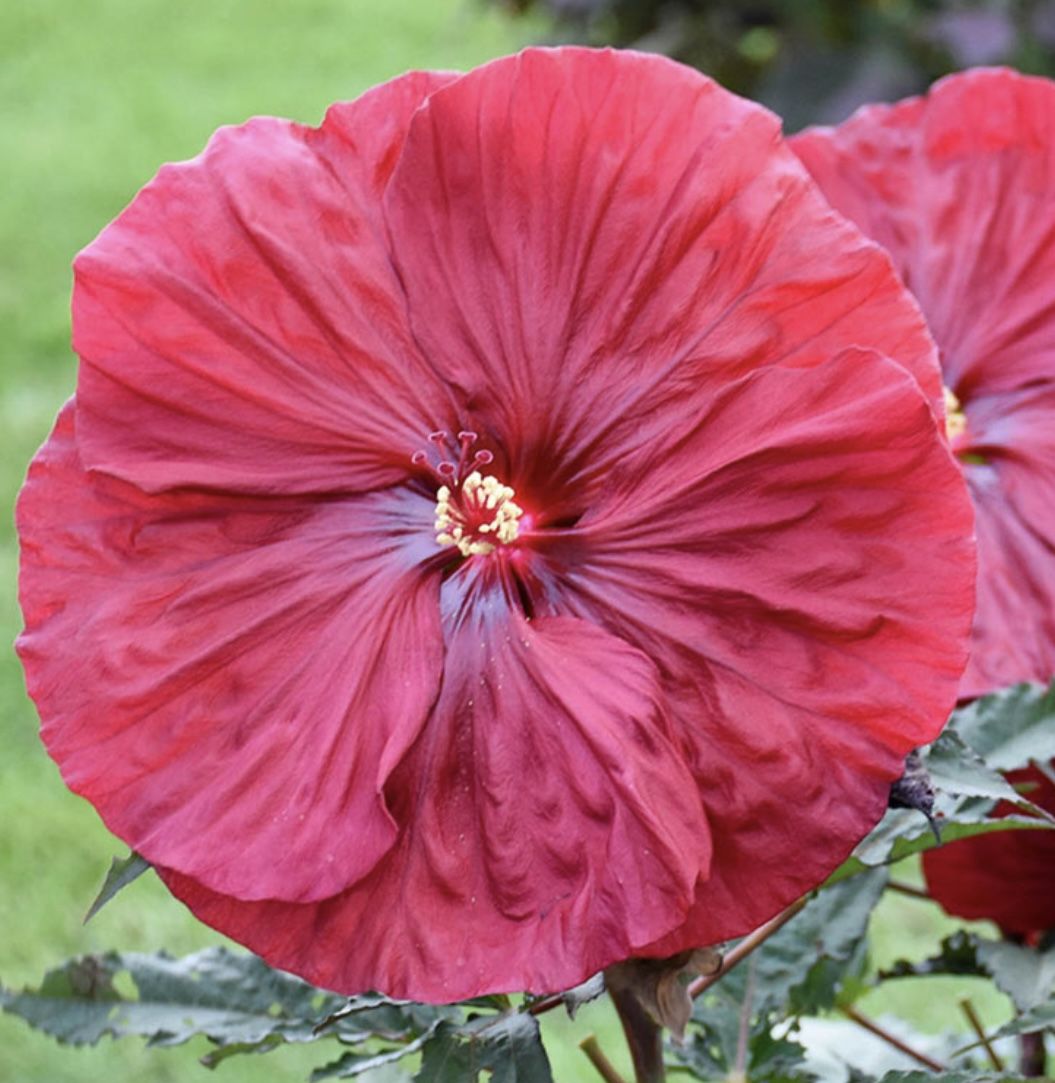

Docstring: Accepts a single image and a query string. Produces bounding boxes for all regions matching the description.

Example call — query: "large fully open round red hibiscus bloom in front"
[18,50,974,1000]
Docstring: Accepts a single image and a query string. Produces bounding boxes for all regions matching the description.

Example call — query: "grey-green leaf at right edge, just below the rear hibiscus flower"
[949,682,1055,771]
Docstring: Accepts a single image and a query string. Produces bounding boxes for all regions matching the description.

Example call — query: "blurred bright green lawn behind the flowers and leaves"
[0,0,1001,1083]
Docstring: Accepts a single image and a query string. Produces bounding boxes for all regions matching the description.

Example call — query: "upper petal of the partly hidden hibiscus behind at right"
[791,69,1055,399]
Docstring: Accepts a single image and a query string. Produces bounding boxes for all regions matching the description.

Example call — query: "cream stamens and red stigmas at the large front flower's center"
[412,432,523,557]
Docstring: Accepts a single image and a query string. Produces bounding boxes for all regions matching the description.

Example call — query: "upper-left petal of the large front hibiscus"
[73,73,454,494]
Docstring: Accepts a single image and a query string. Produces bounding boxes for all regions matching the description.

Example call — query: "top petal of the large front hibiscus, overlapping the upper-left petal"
[386,50,940,492]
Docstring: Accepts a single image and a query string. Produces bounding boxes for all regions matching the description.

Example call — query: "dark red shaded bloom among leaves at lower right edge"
[923,765,1055,937]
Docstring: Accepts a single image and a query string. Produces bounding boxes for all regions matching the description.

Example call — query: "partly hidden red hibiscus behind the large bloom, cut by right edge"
[792,69,1055,699]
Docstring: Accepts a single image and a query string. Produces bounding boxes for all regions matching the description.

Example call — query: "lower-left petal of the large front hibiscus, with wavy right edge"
[17,405,443,900]
